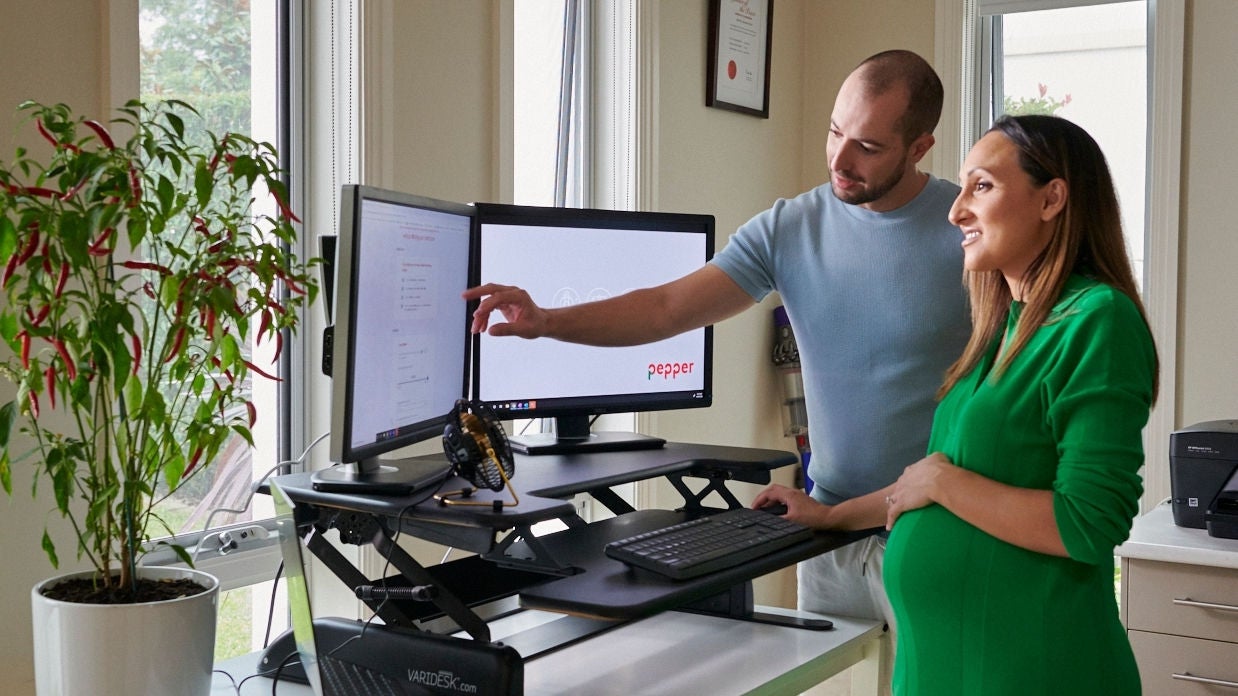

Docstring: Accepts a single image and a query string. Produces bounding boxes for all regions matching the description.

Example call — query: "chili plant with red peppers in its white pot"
[0,100,317,694]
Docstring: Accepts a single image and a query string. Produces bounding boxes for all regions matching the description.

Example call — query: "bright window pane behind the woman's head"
[993,0,1148,282]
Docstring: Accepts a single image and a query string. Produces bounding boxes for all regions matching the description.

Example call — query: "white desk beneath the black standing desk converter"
[212,607,881,696]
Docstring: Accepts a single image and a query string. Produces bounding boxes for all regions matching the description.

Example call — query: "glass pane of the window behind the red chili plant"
[139,0,291,659]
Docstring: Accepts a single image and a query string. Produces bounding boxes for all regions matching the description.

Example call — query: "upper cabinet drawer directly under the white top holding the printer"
[1122,559,1238,643]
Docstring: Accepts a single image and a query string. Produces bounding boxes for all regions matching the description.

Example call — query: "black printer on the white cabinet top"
[1169,420,1238,539]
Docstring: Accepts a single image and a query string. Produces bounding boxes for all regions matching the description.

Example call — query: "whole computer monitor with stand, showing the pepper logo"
[473,203,714,455]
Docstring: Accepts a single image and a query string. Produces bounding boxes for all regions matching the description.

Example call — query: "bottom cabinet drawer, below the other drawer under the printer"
[1128,630,1238,696]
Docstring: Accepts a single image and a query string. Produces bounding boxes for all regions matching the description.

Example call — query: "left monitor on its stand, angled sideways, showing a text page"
[313,185,475,493]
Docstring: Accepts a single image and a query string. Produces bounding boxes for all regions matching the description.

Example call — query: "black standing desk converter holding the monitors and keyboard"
[271,443,867,659]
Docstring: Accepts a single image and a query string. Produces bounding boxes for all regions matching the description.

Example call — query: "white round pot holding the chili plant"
[31,566,219,696]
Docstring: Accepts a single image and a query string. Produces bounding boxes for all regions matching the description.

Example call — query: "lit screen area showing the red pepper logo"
[477,220,711,411]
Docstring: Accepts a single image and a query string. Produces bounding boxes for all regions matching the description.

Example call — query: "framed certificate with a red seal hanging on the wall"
[704,0,774,119]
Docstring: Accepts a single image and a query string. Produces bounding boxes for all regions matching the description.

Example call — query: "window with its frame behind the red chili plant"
[139,0,307,659]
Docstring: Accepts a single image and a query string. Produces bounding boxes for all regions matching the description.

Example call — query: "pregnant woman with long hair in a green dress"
[755,116,1158,696]
